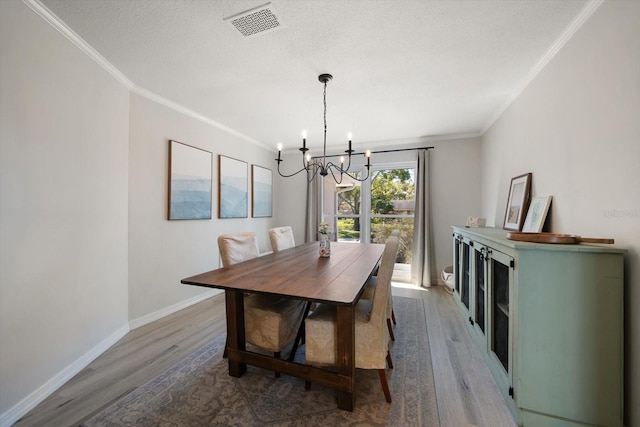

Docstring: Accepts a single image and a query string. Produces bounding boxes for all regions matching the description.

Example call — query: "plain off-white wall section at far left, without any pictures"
[0,0,129,424]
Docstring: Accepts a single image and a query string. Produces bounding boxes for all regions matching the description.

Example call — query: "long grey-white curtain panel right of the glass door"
[411,150,435,287]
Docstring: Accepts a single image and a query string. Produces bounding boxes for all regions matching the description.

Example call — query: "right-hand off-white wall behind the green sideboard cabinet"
[482,1,640,426]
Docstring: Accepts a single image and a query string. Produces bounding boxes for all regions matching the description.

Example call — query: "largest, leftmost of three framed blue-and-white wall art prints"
[168,140,213,220]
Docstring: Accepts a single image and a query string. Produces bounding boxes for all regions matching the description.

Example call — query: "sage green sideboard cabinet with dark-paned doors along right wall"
[453,226,625,427]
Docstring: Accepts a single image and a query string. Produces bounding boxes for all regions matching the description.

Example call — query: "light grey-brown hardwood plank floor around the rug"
[15,284,516,427]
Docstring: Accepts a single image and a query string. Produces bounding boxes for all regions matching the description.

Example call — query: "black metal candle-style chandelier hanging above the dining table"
[276,74,371,184]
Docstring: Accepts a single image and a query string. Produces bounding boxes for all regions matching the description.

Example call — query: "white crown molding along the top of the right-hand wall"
[480,0,604,135]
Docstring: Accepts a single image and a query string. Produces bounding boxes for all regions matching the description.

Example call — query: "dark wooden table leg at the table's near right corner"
[336,305,356,411]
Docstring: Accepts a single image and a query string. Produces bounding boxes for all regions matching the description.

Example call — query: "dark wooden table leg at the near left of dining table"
[224,290,247,377]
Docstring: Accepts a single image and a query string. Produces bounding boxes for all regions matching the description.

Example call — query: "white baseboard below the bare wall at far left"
[0,324,129,427]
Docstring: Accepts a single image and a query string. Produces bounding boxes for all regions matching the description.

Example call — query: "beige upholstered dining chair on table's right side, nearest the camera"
[305,236,398,403]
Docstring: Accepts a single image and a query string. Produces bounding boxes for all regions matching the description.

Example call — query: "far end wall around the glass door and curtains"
[276,138,481,284]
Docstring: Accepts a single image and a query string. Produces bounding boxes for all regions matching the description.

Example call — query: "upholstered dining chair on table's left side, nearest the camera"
[218,232,305,377]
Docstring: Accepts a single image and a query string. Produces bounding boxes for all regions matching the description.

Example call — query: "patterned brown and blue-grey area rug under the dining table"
[82,297,439,427]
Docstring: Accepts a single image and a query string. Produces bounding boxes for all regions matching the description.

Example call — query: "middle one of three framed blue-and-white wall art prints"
[218,155,249,218]
